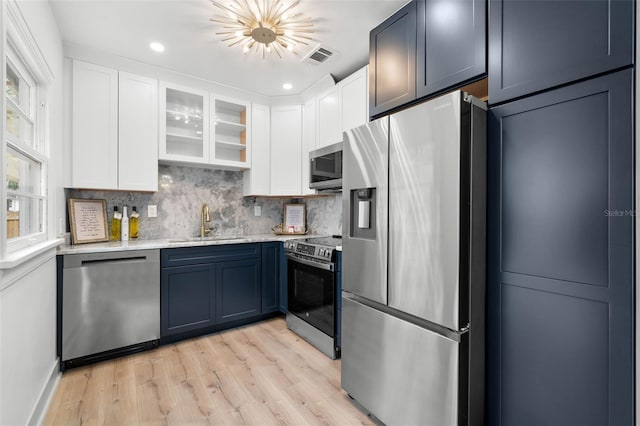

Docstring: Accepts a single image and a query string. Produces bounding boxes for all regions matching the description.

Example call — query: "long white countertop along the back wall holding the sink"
[58,234,318,254]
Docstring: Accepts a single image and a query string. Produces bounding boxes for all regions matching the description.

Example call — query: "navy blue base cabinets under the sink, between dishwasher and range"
[160,242,286,342]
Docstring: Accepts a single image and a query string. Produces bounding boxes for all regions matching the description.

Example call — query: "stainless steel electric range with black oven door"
[284,236,342,359]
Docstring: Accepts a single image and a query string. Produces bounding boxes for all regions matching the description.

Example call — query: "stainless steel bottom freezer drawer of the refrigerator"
[342,293,466,426]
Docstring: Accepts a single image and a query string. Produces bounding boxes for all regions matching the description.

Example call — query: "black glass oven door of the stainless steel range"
[287,255,336,337]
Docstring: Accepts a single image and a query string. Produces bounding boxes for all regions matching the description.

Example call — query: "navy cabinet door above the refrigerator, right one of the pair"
[416,0,486,98]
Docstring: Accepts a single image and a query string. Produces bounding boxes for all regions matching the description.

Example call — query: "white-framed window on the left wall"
[4,40,47,252]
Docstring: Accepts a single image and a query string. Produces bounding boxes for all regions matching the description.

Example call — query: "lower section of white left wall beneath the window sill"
[0,255,58,425]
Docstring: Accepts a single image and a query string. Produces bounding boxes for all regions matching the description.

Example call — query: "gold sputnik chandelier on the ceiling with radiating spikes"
[211,0,313,59]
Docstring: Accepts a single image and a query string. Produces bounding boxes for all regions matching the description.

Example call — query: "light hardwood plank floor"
[44,318,373,426]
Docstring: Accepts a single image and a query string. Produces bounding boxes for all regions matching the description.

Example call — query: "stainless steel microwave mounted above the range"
[309,142,342,191]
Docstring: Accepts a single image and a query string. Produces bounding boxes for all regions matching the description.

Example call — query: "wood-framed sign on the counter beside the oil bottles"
[69,198,109,244]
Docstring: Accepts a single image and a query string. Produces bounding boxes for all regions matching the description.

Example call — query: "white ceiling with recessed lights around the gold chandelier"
[50,0,408,96]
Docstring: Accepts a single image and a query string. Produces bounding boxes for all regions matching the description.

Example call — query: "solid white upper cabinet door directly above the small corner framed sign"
[270,105,302,195]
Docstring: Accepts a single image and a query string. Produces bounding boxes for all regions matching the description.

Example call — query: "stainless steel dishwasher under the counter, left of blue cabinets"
[61,250,160,370]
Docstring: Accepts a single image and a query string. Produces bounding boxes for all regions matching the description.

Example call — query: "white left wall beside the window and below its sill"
[0,0,65,425]
